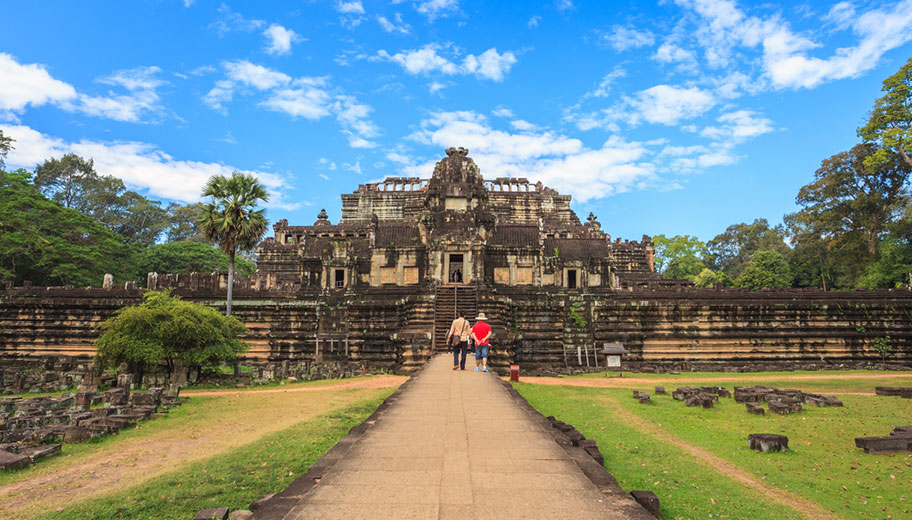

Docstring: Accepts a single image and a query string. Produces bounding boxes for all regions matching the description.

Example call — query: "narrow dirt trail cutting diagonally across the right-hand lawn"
[602,397,838,520]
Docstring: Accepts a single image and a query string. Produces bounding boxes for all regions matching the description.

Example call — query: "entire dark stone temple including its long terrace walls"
[0,148,912,388]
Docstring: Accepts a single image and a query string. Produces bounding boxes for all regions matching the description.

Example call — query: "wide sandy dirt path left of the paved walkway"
[0,376,405,519]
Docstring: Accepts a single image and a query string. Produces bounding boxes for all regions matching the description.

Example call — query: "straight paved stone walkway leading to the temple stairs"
[272,356,652,520]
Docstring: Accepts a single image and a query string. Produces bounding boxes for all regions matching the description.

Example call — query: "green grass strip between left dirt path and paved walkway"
[37,388,393,520]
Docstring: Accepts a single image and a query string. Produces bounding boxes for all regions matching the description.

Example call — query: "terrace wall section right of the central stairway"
[481,289,912,371]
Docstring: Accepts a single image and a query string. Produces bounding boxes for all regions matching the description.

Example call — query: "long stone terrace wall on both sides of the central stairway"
[0,286,912,378]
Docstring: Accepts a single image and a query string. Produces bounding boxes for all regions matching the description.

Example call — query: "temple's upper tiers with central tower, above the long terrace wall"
[251,148,659,291]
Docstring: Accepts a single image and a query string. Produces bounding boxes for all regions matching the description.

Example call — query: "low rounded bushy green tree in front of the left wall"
[95,291,248,381]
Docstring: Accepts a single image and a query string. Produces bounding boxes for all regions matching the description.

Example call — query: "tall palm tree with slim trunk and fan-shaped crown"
[200,172,269,316]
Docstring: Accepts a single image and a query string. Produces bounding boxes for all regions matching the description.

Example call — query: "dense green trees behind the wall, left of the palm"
[0,131,255,286]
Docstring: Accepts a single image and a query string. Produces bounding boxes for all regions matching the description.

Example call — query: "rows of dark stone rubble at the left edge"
[0,377,181,469]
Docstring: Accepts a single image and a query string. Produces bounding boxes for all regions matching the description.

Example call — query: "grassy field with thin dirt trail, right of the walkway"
[516,372,912,519]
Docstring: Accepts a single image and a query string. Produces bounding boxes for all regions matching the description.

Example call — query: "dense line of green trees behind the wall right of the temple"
[653,58,912,290]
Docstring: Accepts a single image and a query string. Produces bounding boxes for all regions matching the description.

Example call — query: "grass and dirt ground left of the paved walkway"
[0,377,404,519]
